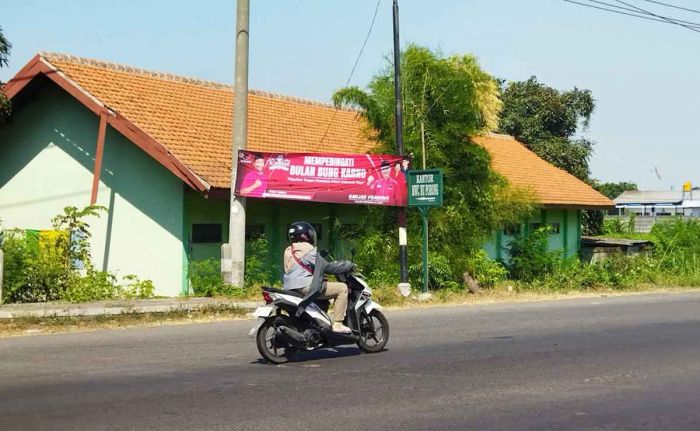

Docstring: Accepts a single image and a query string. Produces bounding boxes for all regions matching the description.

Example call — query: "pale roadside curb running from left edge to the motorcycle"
[0,298,261,319]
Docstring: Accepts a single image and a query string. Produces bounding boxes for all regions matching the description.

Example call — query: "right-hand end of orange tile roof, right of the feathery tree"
[471,133,615,208]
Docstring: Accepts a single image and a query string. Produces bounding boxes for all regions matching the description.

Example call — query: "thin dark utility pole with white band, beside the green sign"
[393,0,411,296]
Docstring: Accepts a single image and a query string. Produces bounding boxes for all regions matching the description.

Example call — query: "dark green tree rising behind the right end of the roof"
[499,76,595,181]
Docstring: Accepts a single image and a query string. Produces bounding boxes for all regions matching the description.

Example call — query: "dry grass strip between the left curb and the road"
[0,306,250,337]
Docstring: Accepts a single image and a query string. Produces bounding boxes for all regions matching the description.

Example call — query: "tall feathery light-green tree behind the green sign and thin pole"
[333,45,532,279]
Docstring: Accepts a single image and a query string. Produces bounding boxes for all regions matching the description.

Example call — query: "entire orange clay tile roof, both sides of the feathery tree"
[35,53,614,208]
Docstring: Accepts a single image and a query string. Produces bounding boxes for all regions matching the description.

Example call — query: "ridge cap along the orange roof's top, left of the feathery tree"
[39,51,360,112]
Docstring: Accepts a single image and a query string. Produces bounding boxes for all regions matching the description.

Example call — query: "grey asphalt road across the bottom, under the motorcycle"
[0,294,700,431]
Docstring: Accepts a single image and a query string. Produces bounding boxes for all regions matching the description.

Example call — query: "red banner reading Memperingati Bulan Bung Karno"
[236,151,409,206]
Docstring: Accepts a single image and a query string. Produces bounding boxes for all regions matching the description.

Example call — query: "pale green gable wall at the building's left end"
[0,83,184,296]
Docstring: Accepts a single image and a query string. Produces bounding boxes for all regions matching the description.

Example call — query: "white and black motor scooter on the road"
[251,273,389,364]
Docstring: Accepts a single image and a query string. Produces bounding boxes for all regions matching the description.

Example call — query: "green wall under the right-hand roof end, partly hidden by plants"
[484,209,581,261]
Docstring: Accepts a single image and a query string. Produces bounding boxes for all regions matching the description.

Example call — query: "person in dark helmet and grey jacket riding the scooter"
[284,221,355,333]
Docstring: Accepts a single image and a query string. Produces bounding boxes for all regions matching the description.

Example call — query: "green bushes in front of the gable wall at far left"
[2,206,154,302]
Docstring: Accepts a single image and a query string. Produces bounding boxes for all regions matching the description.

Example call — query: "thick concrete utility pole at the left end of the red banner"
[221,0,250,287]
